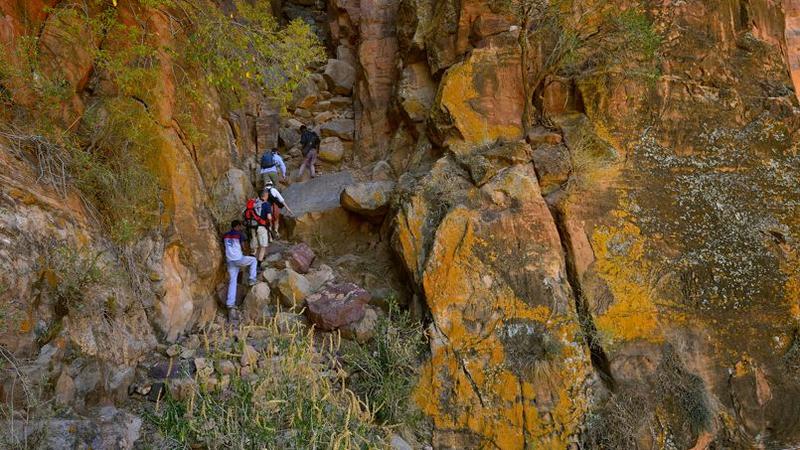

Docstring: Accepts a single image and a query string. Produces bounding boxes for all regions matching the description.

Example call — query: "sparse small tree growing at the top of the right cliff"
[500,0,661,128]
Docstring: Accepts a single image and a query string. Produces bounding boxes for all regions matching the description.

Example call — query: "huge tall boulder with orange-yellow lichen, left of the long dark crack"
[393,149,594,448]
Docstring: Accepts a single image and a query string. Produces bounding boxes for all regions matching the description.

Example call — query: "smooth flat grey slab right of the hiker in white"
[282,172,353,217]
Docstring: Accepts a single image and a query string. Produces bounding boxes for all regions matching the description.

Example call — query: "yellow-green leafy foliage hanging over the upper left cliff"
[0,0,324,244]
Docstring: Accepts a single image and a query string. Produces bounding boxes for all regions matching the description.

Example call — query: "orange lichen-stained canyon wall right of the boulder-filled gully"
[334,0,800,448]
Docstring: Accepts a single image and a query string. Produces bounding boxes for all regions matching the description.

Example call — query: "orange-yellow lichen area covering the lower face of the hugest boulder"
[415,207,590,449]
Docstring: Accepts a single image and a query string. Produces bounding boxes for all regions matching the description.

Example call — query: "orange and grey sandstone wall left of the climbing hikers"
[0,1,264,414]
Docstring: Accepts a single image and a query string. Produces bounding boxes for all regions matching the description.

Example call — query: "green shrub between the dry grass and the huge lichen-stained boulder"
[342,301,426,426]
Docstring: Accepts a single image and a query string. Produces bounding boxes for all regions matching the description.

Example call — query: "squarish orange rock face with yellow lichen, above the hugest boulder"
[440,49,522,144]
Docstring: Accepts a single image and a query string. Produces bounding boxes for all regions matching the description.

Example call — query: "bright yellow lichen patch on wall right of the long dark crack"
[592,214,663,342]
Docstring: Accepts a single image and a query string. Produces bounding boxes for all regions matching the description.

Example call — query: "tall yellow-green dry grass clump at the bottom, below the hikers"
[150,316,394,449]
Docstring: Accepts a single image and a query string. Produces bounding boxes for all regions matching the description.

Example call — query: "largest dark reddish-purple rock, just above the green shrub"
[306,283,372,331]
